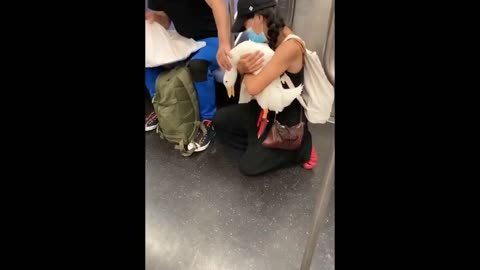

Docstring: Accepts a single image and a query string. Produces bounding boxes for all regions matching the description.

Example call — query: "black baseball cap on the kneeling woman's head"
[231,0,277,33]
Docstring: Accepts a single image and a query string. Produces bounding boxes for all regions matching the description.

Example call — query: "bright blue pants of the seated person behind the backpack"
[145,37,219,120]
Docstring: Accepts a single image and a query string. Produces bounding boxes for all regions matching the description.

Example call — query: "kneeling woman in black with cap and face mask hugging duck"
[213,0,317,175]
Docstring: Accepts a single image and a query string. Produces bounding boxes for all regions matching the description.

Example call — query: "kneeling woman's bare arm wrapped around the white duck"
[243,41,303,95]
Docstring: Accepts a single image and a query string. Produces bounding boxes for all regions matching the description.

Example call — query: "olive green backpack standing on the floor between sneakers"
[153,65,201,156]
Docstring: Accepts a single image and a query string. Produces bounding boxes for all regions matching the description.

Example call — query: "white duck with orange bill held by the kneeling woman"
[223,40,303,120]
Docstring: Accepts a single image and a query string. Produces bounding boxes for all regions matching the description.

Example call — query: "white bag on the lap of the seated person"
[145,20,206,68]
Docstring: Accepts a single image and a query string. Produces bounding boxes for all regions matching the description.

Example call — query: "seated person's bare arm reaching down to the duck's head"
[205,0,232,70]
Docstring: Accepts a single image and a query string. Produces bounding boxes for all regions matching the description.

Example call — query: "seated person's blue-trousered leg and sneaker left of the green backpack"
[145,67,163,131]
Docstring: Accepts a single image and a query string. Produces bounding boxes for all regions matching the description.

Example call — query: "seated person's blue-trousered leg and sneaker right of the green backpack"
[188,38,218,152]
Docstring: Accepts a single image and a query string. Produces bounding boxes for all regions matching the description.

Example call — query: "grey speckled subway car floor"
[145,123,335,270]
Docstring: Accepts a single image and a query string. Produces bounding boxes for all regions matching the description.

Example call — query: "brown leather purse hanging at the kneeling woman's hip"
[262,108,305,150]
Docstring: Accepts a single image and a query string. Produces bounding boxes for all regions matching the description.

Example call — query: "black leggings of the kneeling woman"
[213,101,312,176]
